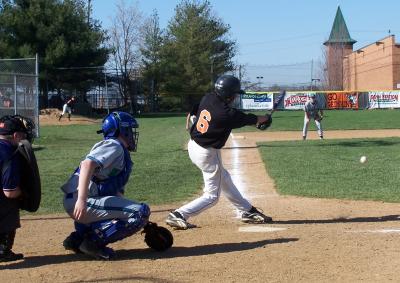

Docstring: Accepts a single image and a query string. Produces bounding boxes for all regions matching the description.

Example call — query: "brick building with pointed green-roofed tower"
[324,7,400,90]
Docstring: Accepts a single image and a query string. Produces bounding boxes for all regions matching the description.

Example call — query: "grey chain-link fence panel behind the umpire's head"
[0,57,39,136]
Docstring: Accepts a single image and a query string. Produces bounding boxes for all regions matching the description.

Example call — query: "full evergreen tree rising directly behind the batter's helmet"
[163,0,236,109]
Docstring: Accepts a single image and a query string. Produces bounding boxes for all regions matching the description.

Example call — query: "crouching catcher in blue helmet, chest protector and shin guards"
[61,112,172,260]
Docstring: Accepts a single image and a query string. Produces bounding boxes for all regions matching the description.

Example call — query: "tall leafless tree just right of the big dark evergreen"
[109,0,144,113]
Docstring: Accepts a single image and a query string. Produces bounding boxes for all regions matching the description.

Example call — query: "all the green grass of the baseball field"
[35,110,400,213]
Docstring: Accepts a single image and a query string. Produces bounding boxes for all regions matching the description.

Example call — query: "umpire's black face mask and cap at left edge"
[0,115,35,143]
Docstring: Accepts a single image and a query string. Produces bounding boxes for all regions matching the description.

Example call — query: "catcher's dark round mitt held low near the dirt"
[142,222,174,252]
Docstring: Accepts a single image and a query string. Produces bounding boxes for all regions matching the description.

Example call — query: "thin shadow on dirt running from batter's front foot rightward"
[273,215,400,224]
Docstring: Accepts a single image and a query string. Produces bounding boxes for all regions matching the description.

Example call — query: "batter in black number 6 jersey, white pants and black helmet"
[166,75,272,230]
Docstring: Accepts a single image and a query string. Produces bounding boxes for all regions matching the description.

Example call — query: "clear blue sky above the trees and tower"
[91,0,400,85]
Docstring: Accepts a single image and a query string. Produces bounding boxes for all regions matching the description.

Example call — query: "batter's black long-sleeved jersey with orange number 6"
[190,93,257,151]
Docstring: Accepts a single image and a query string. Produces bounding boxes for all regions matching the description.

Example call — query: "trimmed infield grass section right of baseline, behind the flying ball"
[259,138,400,202]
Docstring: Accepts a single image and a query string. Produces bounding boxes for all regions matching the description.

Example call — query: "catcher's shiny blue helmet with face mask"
[97,112,139,151]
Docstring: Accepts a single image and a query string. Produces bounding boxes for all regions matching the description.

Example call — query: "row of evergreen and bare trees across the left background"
[0,0,236,110]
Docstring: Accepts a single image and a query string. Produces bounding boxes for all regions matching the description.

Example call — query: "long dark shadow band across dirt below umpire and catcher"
[0,238,299,270]
